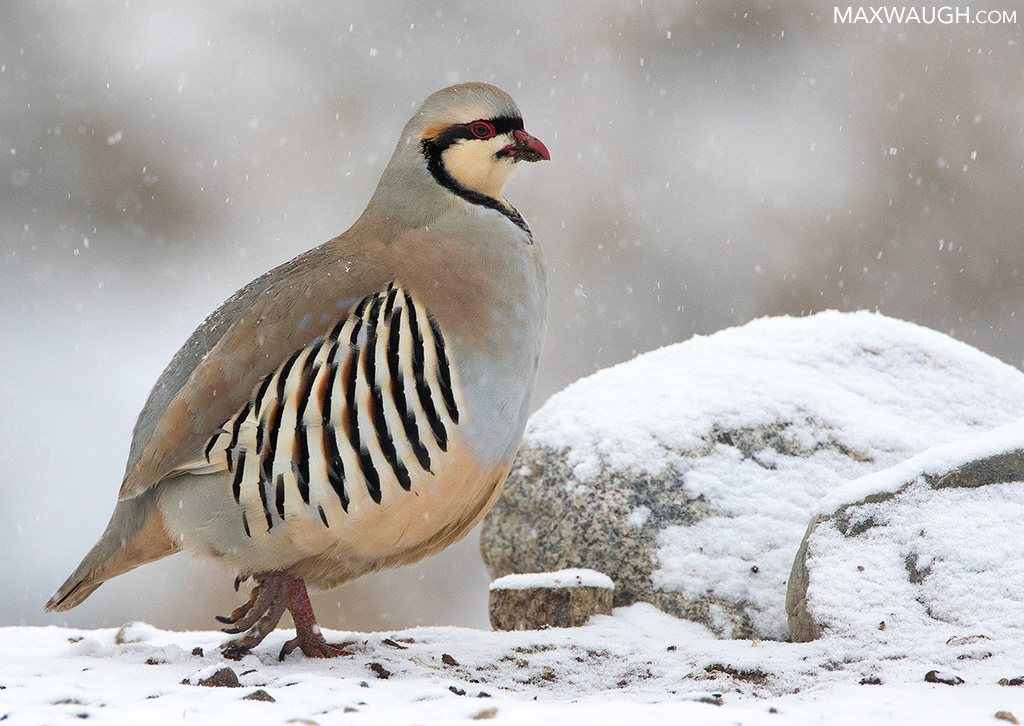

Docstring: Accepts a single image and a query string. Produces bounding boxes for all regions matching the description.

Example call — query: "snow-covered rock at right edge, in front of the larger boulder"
[786,423,1024,652]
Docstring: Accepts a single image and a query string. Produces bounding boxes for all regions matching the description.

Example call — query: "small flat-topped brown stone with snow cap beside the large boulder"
[488,570,614,631]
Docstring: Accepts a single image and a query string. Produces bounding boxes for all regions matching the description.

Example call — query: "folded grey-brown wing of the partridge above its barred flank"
[119,238,389,500]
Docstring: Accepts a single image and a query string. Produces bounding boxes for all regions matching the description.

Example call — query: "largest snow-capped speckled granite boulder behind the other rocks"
[481,312,1024,639]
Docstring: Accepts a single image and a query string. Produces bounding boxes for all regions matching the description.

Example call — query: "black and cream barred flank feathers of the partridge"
[193,285,460,537]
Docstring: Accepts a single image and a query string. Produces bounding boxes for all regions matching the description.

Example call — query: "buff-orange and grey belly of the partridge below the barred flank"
[159,434,509,588]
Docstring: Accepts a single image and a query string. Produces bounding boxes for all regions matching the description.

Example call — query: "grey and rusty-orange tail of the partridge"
[44,488,180,611]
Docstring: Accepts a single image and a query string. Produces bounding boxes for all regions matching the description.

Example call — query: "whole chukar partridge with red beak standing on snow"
[46,83,550,657]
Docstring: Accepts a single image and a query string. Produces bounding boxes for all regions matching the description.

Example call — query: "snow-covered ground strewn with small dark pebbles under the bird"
[6,604,1024,726]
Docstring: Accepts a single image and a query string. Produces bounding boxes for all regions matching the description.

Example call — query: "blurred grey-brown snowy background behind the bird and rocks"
[0,0,1024,630]
